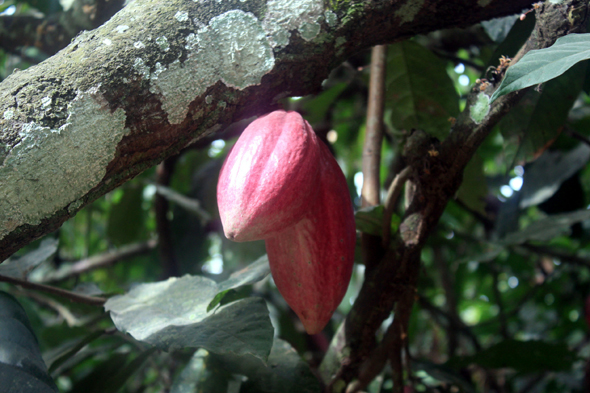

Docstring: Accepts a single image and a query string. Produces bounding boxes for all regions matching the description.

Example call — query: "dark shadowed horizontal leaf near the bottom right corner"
[448,339,577,373]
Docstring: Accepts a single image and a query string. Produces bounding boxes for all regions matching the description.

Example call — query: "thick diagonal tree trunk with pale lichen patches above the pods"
[0,0,532,261]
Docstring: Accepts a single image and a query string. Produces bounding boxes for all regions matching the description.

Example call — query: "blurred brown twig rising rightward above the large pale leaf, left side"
[41,239,158,283]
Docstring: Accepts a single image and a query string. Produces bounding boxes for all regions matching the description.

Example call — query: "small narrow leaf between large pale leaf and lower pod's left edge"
[207,254,270,312]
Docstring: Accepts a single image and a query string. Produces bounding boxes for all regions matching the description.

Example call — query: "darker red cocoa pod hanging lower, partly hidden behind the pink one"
[266,142,356,334]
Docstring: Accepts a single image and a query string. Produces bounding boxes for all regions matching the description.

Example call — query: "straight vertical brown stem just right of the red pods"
[361,45,387,270]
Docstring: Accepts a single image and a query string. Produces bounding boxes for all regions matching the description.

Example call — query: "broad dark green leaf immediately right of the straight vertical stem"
[385,40,459,139]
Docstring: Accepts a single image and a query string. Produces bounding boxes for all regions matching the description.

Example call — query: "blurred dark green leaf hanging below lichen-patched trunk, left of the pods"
[107,185,144,245]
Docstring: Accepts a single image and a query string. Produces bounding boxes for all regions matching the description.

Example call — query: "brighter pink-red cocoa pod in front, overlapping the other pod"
[217,110,321,242]
